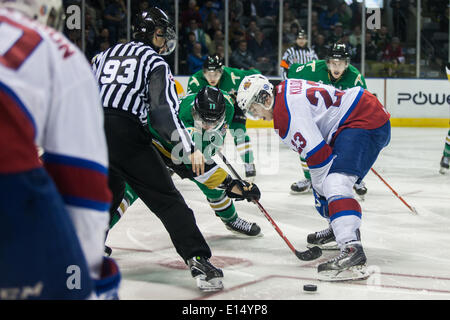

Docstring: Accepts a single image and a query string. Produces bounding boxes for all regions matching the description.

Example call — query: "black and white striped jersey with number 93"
[92,42,194,151]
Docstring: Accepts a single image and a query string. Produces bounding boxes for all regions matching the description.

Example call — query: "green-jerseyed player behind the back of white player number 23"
[288,43,367,199]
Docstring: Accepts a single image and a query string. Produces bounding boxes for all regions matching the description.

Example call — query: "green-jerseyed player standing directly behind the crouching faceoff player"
[187,55,261,181]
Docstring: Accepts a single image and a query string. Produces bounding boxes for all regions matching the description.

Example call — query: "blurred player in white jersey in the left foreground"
[0,0,120,299]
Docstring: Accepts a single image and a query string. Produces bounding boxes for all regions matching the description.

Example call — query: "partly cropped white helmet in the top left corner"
[0,0,64,30]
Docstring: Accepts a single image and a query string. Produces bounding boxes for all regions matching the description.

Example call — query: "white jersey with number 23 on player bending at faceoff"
[273,79,390,194]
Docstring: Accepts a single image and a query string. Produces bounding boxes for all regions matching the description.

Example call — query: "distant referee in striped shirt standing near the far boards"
[280,29,318,80]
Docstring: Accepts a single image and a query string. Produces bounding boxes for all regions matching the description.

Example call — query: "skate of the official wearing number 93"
[187,257,223,292]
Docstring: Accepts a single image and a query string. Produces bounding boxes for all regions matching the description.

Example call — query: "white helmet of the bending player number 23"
[236,74,273,113]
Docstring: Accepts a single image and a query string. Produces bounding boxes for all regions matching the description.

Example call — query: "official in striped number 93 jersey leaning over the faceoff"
[93,8,223,291]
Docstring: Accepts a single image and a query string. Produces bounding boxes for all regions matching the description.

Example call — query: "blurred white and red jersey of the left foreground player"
[0,9,111,278]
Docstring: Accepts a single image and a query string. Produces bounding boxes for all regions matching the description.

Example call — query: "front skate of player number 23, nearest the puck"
[317,241,370,281]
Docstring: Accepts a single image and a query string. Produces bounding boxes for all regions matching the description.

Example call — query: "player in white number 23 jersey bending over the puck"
[237,75,390,281]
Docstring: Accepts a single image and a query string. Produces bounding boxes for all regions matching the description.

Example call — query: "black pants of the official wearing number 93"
[105,112,211,261]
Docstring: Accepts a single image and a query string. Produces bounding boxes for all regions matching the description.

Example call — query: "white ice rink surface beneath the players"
[107,128,450,300]
